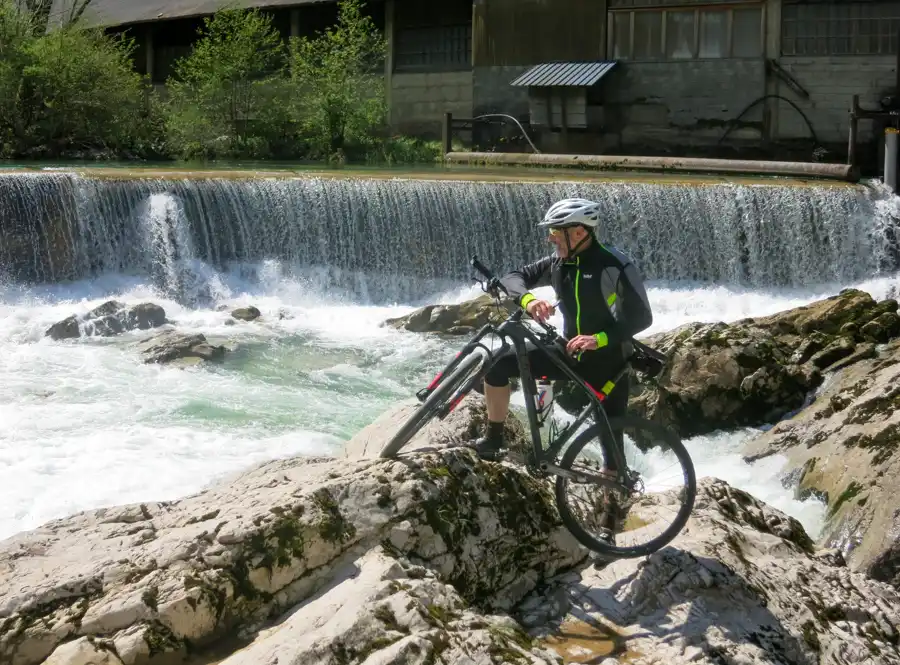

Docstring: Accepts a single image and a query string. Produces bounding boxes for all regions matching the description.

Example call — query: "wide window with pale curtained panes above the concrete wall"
[609,3,764,60]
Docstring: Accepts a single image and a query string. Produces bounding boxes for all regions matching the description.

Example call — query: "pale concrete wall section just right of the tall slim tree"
[391,70,473,138]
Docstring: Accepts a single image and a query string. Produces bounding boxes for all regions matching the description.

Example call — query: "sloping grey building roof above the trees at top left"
[50,0,334,27]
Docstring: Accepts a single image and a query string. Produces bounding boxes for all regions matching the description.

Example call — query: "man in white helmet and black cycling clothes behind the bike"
[473,198,653,556]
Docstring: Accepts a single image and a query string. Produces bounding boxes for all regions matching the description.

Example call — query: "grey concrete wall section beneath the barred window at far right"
[773,56,897,144]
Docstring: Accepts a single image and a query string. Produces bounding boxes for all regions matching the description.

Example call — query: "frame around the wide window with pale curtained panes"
[606,2,766,63]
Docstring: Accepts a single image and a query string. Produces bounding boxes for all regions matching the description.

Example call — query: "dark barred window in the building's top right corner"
[781,0,900,55]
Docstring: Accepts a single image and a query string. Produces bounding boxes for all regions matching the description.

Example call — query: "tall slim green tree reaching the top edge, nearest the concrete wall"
[291,0,387,157]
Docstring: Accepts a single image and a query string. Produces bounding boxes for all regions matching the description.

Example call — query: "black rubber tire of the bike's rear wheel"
[556,416,697,559]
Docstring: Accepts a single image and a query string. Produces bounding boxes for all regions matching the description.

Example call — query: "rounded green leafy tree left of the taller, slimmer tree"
[167,9,288,157]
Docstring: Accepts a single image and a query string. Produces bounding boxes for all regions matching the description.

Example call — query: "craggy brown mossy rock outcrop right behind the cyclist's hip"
[624,289,900,437]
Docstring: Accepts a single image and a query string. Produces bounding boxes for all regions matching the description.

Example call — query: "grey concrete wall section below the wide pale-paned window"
[599,58,765,149]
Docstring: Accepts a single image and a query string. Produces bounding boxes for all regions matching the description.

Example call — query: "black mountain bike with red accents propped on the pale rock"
[381,257,697,559]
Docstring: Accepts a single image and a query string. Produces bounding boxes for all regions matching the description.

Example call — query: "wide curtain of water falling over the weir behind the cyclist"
[0,172,897,300]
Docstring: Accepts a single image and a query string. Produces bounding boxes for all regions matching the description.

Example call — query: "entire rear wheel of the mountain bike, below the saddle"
[556,417,697,559]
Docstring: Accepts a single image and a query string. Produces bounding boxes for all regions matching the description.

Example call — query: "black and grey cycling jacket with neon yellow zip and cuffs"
[500,240,653,360]
